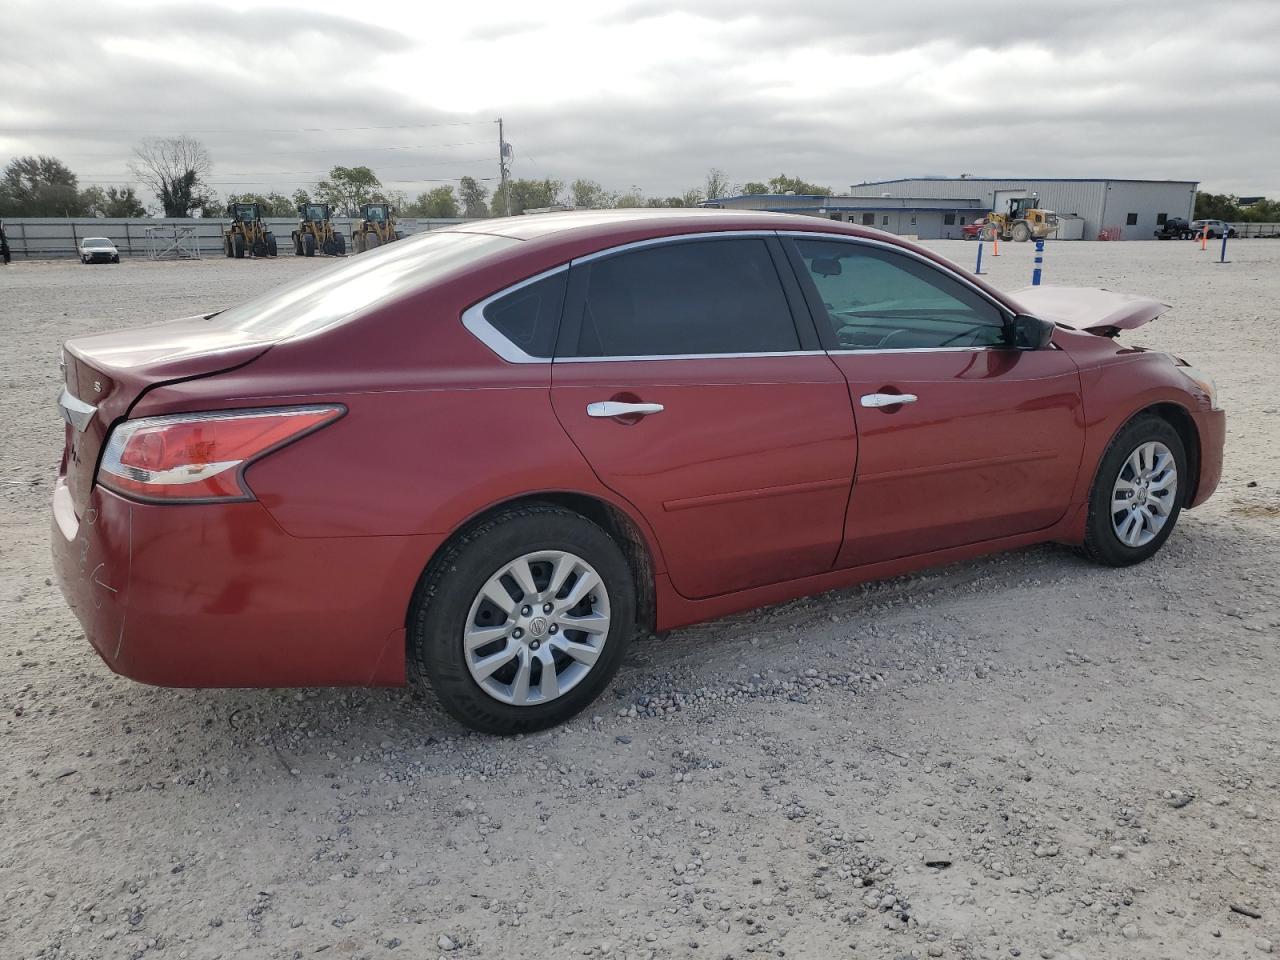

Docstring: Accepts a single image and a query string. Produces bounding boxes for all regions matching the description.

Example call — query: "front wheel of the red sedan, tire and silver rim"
[1084,415,1189,567]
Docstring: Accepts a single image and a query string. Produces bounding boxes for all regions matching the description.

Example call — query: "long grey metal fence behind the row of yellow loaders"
[4,216,478,260]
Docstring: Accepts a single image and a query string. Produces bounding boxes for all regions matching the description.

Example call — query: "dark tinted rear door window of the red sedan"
[566,238,800,357]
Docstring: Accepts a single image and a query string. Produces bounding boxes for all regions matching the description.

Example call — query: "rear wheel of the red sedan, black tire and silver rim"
[408,504,636,735]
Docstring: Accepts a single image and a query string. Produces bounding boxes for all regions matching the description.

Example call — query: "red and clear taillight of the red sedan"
[99,406,346,500]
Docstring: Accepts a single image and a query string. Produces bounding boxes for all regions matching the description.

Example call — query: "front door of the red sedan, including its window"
[786,238,1084,566]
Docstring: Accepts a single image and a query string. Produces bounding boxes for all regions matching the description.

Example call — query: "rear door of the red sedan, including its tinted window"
[552,234,856,598]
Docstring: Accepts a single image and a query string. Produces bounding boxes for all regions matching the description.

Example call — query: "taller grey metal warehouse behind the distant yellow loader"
[841,177,1199,239]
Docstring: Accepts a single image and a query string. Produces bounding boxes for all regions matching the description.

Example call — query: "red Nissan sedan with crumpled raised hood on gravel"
[52,210,1224,733]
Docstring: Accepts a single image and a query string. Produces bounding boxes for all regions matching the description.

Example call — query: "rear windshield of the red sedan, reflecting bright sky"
[209,230,520,338]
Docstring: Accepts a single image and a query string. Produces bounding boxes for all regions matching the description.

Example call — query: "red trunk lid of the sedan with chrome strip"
[59,316,275,517]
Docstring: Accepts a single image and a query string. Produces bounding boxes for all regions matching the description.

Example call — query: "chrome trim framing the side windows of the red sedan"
[462,230,1014,364]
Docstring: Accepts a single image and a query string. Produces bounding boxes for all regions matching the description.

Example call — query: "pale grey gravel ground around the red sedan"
[0,241,1280,960]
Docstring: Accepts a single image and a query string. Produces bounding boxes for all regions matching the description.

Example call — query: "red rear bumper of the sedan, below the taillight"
[51,480,440,687]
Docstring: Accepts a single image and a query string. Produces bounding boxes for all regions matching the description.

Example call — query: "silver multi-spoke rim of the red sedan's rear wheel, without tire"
[461,550,609,707]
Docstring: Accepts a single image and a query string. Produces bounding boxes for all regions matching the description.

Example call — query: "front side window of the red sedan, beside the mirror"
[795,239,1007,349]
